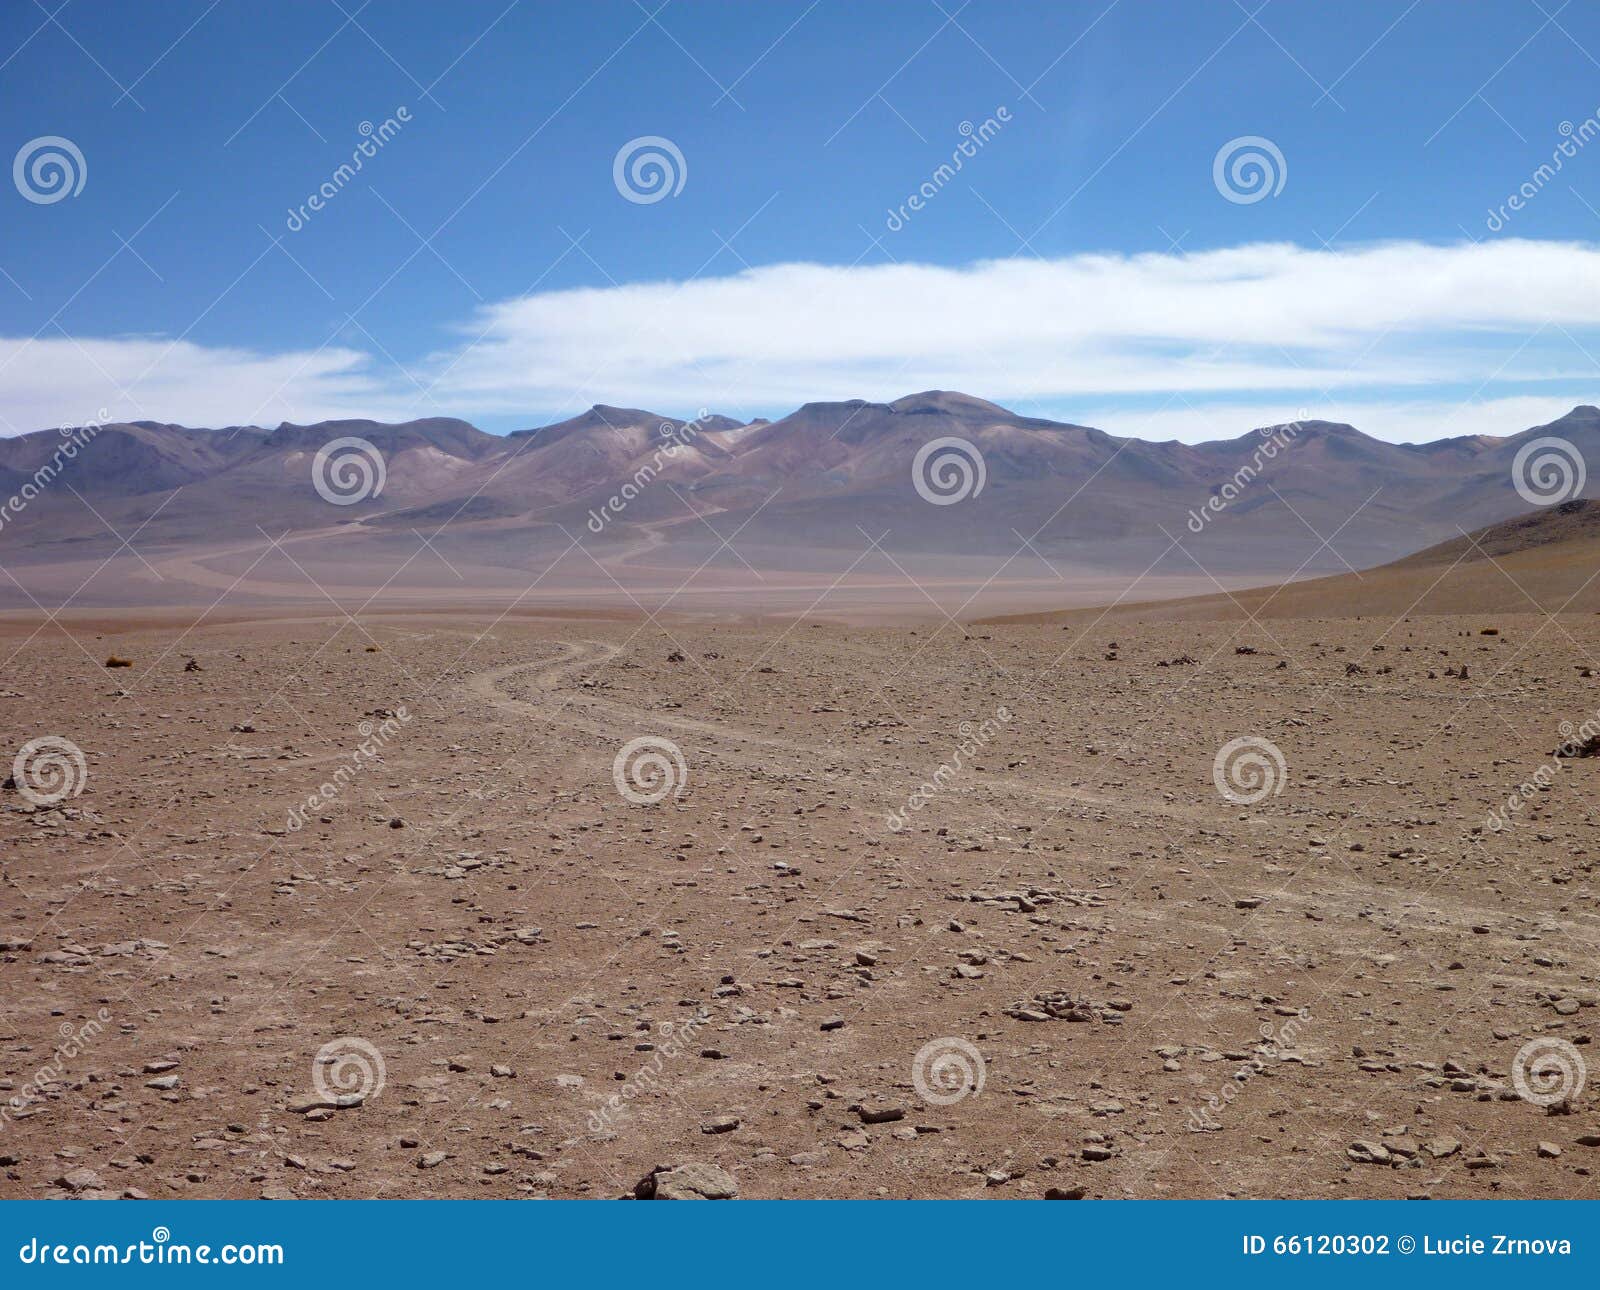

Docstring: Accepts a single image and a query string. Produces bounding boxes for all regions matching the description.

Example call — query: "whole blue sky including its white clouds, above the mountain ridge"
[0,0,1600,439]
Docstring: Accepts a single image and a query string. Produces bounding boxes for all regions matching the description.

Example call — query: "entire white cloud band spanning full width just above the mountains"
[0,238,1600,439]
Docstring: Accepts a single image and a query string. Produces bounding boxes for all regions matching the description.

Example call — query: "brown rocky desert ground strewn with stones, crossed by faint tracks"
[0,615,1600,1197]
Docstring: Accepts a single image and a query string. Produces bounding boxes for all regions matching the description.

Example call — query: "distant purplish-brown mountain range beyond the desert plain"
[0,391,1600,614]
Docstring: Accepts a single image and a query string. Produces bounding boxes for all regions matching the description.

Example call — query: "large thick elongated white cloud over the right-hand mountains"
[437,240,1600,410]
